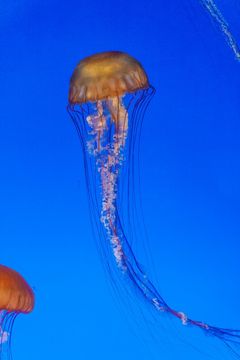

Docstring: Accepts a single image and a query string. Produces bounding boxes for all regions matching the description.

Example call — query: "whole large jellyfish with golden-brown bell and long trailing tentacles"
[67,51,240,358]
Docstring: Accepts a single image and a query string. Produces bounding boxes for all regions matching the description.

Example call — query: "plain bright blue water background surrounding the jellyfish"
[0,0,240,360]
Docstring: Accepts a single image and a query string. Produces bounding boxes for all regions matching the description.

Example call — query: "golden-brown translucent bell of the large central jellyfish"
[69,51,149,105]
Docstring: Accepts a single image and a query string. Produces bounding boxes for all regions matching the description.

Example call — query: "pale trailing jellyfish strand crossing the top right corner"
[200,0,240,61]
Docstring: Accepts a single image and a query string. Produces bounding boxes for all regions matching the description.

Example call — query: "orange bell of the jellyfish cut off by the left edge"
[0,265,34,313]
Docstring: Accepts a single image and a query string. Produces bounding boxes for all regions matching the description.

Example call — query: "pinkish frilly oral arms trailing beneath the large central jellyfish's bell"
[81,93,240,354]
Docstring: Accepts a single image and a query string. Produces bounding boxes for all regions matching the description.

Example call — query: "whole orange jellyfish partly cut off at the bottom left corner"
[0,265,34,359]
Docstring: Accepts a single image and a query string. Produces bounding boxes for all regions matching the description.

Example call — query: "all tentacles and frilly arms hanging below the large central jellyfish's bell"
[68,89,240,357]
